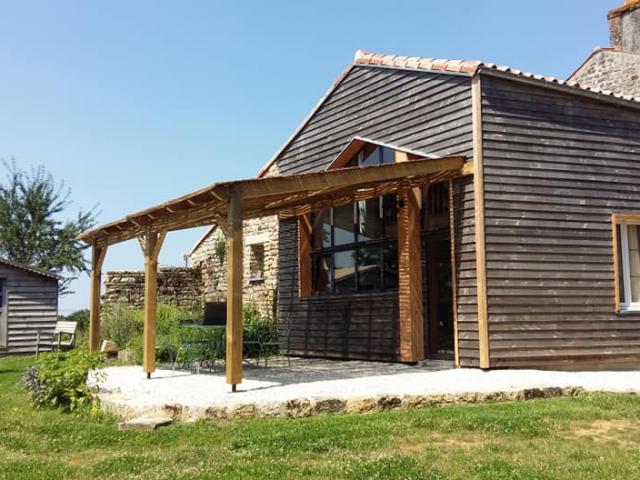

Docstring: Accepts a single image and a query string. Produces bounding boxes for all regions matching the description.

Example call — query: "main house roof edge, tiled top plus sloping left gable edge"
[258,49,640,177]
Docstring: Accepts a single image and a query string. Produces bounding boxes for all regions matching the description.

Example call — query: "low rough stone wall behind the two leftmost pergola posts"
[102,267,202,310]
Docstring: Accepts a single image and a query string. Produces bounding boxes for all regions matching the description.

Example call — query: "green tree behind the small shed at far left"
[0,160,96,295]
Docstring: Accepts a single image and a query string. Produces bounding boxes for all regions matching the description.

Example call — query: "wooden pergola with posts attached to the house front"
[79,149,469,391]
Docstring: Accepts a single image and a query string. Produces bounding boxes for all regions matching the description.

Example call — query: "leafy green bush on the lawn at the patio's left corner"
[23,348,101,411]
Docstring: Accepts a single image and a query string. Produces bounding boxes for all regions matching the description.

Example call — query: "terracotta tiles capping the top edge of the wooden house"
[354,49,640,102]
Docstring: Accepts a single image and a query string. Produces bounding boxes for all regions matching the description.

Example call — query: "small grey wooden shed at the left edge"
[0,258,60,355]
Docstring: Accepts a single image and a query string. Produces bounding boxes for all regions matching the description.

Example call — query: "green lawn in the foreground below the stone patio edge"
[0,357,640,480]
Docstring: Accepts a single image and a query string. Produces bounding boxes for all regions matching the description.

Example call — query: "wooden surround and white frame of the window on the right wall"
[611,213,640,313]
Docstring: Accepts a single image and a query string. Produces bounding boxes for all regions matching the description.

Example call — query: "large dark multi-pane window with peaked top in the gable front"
[311,145,398,295]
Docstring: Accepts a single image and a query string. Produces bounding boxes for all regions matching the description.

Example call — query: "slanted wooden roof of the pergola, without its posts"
[78,156,464,247]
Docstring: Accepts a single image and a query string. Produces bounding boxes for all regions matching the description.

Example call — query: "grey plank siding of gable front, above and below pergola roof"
[277,66,478,366]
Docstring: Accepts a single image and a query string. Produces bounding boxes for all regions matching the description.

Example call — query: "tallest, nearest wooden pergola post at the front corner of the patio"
[225,188,243,392]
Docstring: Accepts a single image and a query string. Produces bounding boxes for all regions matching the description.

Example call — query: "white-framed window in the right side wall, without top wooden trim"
[616,223,640,311]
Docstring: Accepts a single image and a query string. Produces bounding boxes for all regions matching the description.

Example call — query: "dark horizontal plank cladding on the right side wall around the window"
[482,76,640,367]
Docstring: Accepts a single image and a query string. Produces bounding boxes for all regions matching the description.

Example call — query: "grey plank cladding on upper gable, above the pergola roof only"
[277,66,471,175]
